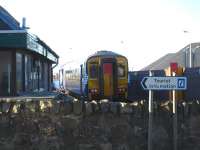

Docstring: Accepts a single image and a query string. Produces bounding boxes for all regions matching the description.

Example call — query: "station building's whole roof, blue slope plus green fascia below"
[0,6,59,63]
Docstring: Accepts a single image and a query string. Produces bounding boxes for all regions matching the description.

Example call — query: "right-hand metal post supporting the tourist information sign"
[172,72,177,150]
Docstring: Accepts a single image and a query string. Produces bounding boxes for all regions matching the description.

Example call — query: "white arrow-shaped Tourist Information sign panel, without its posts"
[141,76,187,90]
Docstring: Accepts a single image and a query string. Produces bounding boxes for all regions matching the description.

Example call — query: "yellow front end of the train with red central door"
[87,51,128,99]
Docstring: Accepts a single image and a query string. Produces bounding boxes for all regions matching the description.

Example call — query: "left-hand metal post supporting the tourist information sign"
[148,71,153,150]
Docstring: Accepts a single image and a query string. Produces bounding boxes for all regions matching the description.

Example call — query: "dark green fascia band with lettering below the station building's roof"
[0,30,59,63]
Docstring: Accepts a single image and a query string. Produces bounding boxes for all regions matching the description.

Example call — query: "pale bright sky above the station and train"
[0,0,200,71]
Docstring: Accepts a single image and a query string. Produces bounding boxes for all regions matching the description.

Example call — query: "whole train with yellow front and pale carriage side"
[59,50,128,100]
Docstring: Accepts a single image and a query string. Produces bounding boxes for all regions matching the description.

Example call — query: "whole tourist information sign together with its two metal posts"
[141,75,187,150]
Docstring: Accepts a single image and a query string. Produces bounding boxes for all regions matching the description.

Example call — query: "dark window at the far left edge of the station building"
[0,51,11,96]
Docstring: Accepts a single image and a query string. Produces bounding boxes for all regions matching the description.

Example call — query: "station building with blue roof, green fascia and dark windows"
[0,6,59,96]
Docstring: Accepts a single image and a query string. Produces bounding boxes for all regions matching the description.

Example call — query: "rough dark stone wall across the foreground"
[0,99,200,150]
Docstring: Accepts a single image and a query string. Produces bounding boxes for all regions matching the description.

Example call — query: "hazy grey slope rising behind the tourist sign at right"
[142,43,200,71]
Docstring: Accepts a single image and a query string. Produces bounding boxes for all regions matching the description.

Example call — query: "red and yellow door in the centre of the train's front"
[102,59,115,98]
